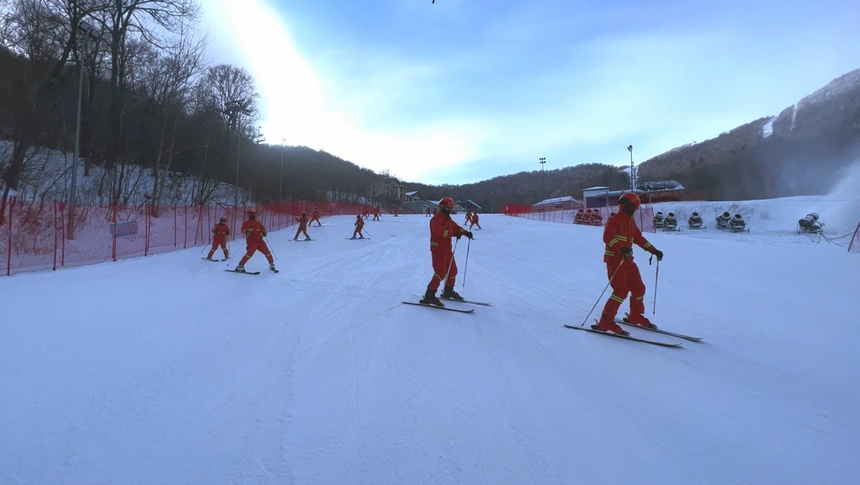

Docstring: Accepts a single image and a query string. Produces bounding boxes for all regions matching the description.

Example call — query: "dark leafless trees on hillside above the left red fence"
[0,0,381,220]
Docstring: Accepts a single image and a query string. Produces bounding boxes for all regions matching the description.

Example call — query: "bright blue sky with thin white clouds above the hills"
[203,0,860,184]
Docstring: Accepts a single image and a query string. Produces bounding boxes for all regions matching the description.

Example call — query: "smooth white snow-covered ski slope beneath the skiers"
[0,198,860,484]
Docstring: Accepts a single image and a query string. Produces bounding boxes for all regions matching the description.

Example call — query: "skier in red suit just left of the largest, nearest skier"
[421,197,472,306]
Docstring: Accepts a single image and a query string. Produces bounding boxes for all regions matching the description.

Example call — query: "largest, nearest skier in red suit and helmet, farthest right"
[591,192,663,335]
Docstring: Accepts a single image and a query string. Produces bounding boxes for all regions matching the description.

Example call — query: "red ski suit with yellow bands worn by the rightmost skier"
[601,211,655,321]
